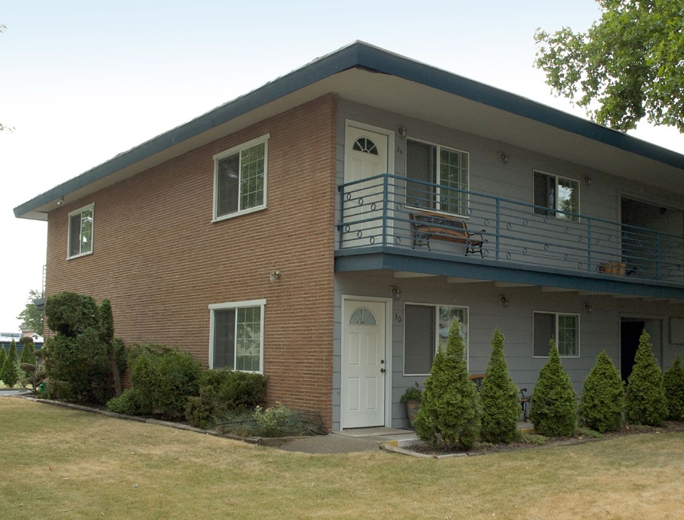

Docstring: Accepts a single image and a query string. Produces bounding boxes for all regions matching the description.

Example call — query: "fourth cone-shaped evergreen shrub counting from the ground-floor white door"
[580,350,625,433]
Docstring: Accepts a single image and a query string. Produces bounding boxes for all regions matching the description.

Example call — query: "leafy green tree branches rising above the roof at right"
[535,0,684,132]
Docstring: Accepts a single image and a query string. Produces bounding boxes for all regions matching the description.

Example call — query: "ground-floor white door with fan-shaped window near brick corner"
[342,300,387,428]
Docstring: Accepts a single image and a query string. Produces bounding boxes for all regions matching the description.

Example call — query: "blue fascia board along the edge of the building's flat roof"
[14,42,684,217]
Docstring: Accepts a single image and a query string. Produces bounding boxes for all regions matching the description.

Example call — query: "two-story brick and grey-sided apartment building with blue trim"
[15,42,684,429]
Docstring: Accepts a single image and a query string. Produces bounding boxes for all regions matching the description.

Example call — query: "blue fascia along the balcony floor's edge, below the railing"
[335,246,684,300]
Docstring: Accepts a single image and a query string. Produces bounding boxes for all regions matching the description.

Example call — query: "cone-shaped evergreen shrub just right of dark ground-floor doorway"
[625,331,667,426]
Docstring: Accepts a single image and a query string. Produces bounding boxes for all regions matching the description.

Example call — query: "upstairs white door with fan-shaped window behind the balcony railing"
[342,124,390,247]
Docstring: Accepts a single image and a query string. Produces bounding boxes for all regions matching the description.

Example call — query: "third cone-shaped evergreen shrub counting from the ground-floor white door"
[530,340,577,437]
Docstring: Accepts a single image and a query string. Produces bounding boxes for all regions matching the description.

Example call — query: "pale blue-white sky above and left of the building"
[0,0,684,332]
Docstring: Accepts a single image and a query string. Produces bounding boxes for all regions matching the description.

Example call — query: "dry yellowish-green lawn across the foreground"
[0,397,684,520]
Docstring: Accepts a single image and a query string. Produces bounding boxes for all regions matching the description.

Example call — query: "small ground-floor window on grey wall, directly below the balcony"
[533,312,579,357]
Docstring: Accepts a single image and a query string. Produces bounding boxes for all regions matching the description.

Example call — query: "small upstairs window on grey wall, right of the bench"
[534,171,579,222]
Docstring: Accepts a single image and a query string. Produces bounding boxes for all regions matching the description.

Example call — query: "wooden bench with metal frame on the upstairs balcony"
[409,211,487,256]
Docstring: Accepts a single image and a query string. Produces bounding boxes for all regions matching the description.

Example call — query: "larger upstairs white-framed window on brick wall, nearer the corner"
[214,135,269,219]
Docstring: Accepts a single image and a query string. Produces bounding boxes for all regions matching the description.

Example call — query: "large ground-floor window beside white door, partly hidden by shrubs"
[404,305,468,375]
